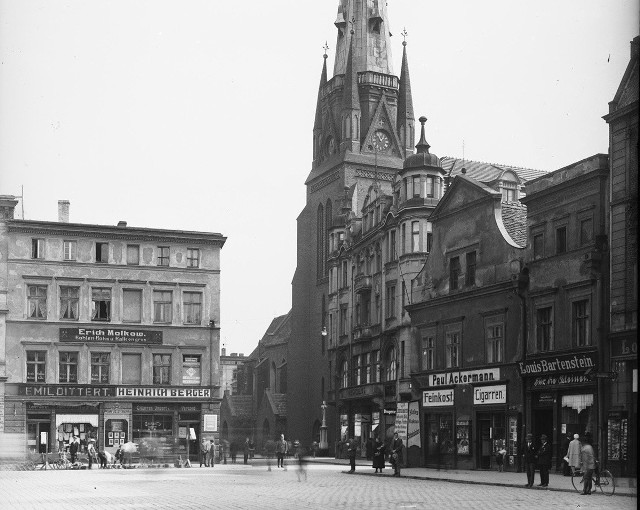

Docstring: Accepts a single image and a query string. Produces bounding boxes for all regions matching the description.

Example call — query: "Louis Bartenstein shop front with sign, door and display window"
[519,352,604,470]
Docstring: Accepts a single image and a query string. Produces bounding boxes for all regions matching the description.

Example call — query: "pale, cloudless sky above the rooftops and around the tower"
[0,0,639,354]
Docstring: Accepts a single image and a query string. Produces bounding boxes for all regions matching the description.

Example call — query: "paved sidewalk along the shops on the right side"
[308,457,638,497]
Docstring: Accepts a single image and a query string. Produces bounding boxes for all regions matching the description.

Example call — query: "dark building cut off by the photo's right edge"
[604,37,640,476]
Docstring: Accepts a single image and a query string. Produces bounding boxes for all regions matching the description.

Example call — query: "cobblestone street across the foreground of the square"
[0,465,637,510]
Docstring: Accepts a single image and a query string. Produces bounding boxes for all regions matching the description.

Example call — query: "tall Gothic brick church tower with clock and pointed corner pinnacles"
[286,0,415,448]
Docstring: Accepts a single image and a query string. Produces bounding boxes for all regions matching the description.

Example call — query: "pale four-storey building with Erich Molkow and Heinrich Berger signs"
[0,196,226,458]
